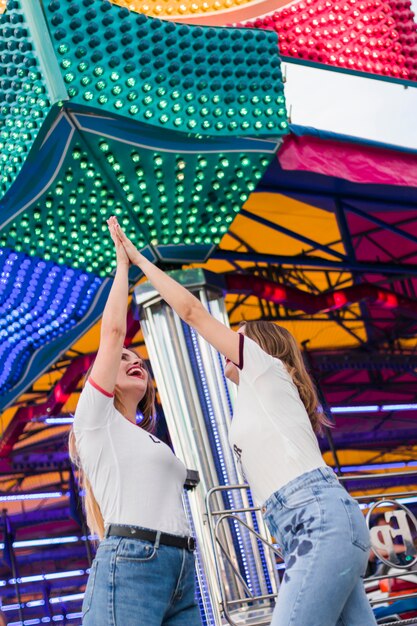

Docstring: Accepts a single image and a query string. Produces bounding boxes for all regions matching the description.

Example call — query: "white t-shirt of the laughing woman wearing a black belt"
[74,378,190,536]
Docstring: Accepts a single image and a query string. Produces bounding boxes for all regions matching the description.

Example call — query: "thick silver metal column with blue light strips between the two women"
[134,269,275,626]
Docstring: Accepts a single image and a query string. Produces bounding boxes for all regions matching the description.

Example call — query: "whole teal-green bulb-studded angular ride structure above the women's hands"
[0,0,288,276]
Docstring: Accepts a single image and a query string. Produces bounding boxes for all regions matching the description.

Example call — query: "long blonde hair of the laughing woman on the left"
[68,354,156,541]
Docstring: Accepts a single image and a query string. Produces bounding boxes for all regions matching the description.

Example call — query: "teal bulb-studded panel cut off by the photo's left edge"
[0,0,51,198]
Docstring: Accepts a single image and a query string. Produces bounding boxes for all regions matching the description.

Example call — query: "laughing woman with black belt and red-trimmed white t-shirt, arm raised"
[70,222,201,626]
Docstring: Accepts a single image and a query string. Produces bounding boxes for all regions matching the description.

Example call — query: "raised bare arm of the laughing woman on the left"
[91,218,130,393]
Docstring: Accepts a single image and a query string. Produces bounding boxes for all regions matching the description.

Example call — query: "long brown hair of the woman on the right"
[239,320,330,433]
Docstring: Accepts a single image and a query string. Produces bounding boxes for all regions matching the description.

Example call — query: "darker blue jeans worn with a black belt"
[82,537,201,626]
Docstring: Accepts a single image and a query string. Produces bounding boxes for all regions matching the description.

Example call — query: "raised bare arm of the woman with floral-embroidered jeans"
[116,222,239,364]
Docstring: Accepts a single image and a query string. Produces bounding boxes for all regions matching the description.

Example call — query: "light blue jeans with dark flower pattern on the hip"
[262,467,376,626]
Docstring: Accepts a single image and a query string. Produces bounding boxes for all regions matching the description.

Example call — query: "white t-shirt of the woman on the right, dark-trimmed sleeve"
[229,334,326,504]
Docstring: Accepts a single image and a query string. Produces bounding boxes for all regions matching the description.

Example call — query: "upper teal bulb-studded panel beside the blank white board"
[44,0,287,137]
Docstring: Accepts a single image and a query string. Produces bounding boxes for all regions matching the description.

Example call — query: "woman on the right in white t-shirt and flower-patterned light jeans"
[111,218,376,626]
